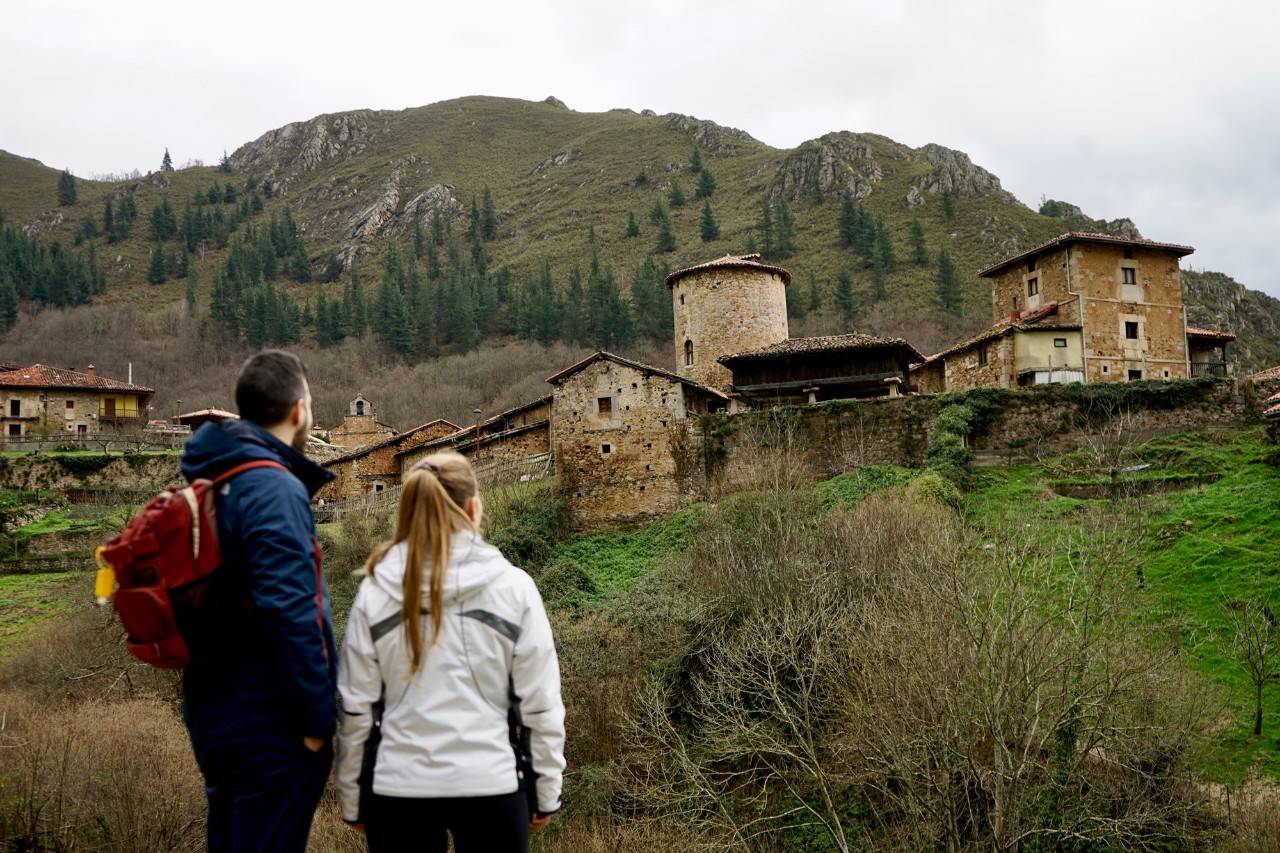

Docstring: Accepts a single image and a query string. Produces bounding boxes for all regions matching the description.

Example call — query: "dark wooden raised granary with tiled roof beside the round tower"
[718,334,924,407]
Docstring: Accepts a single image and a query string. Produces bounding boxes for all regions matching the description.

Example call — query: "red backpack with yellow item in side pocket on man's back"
[95,460,288,670]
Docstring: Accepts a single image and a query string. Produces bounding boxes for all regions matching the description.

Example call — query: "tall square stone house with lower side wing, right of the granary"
[911,232,1234,392]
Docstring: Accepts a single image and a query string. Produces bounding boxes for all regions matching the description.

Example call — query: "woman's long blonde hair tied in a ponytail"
[365,452,477,674]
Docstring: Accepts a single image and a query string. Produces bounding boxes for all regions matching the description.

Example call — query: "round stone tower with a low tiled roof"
[667,255,791,388]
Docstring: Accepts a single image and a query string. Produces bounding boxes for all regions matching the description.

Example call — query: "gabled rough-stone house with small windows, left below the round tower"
[547,352,730,526]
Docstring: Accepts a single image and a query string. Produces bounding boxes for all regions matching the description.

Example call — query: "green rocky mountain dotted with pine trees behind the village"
[0,97,1280,427]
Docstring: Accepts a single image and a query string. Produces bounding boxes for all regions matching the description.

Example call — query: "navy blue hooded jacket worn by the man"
[182,420,337,754]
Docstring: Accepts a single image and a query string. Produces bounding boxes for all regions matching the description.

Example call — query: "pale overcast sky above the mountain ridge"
[0,0,1280,296]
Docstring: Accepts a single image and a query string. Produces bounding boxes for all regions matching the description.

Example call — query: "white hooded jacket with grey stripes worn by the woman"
[334,532,564,821]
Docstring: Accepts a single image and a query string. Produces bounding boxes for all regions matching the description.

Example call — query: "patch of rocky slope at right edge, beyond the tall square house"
[1183,269,1280,375]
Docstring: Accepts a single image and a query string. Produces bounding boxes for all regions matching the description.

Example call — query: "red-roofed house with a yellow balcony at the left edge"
[0,364,155,441]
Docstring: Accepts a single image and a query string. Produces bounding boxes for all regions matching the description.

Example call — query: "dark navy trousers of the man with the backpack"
[196,735,333,853]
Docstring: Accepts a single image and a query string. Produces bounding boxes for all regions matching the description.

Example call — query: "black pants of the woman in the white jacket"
[365,790,529,853]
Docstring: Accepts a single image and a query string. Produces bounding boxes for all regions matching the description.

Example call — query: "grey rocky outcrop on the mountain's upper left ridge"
[230,110,387,174]
